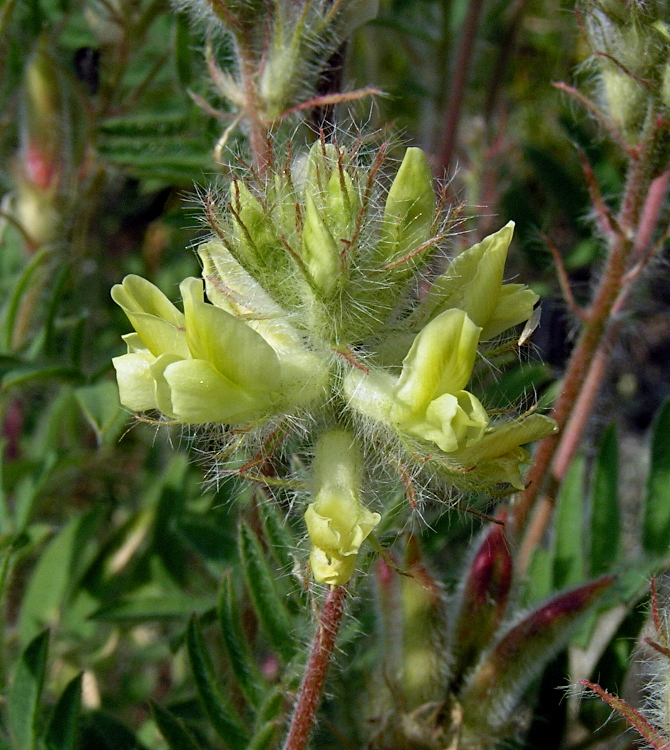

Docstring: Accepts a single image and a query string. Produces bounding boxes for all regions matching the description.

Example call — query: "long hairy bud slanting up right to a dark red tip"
[459,576,614,739]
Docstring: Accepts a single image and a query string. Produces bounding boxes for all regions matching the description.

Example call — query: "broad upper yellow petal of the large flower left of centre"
[180,278,281,393]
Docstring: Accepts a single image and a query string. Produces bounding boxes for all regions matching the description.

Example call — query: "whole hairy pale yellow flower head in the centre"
[113,141,555,584]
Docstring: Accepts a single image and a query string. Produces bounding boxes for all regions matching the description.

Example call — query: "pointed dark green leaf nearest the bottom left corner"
[7,630,49,750]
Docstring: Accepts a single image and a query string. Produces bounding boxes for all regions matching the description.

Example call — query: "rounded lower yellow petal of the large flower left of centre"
[163,359,270,424]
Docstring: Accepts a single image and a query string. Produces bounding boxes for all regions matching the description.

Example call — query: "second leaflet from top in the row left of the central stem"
[218,571,265,706]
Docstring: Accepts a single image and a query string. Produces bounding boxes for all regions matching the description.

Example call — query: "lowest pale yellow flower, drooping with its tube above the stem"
[305,429,381,586]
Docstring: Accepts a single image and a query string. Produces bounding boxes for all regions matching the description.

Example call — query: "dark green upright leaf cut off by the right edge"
[642,400,670,555]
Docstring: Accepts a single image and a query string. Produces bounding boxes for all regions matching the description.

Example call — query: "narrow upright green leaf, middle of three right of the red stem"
[589,424,620,577]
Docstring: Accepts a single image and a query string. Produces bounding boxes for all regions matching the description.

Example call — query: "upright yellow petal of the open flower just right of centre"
[391,309,481,418]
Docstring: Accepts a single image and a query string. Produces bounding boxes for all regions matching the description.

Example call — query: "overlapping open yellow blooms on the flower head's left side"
[112,276,324,424]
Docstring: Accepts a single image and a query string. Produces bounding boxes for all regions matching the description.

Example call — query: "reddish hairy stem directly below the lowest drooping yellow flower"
[284,586,347,750]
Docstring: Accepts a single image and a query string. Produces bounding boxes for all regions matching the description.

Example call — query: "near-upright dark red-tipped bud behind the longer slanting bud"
[452,524,513,683]
